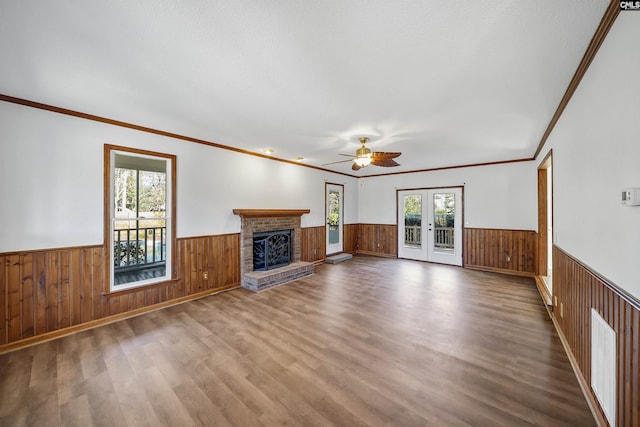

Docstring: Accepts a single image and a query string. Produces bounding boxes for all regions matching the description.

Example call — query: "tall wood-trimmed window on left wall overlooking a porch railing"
[105,146,175,292]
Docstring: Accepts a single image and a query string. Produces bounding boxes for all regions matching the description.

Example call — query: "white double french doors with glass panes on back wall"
[398,187,462,265]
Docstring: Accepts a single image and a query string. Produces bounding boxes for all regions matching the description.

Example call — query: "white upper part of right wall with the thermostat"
[540,12,640,298]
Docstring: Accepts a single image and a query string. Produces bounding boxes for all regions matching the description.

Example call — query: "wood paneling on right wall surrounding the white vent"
[553,246,640,426]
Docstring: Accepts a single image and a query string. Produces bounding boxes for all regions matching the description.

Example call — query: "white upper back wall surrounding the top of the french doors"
[358,161,538,230]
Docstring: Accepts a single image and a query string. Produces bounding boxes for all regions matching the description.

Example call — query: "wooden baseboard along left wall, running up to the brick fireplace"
[0,283,240,354]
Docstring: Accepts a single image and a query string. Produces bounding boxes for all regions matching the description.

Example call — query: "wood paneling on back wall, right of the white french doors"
[464,228,537,275]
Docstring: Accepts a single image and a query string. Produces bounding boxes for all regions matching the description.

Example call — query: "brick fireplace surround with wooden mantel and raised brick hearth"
[233,209,313,292]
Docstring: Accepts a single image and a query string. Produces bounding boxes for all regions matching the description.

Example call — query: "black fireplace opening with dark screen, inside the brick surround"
[253,230,293,271]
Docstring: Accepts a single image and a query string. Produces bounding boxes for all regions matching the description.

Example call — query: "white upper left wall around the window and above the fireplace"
[0,102,358,252]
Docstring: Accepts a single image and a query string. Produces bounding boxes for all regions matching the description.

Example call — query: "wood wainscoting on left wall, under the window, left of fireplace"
[0,234,240,351]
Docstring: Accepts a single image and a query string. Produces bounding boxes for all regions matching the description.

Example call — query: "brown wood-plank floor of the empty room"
[0,256,595,426]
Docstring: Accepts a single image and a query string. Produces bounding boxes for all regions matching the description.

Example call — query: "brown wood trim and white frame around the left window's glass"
[103,144,177,295]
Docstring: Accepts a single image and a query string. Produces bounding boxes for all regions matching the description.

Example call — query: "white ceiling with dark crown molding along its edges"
[0,0,608,176]
